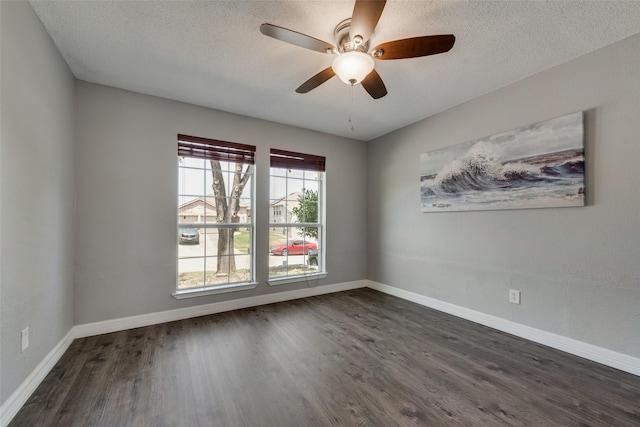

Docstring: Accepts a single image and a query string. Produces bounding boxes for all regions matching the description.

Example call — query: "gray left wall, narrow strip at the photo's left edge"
[0,1,75,408]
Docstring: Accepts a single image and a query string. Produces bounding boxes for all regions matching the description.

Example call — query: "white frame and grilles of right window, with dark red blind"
[267,148,328,286]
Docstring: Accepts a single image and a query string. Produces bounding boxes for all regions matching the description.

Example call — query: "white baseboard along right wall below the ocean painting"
[368,280,640,375]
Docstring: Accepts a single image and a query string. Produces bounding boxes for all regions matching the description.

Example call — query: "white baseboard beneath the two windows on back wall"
[74,280,368,338]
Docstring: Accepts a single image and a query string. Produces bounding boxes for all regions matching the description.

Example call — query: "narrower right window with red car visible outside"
[269,149,326,284]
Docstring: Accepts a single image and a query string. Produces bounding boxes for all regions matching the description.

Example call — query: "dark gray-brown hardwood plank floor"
[10,289,640,427]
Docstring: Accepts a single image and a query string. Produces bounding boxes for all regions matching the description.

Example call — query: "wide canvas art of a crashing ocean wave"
[420,112,585,212]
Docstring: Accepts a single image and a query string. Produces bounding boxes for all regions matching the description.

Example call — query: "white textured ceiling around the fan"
[31,0,640,141]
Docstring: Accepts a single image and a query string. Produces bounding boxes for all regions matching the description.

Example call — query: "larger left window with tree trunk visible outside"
[174,135,256,298]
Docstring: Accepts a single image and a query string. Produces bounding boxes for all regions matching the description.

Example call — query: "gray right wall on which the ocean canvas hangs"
[368,36,640,357]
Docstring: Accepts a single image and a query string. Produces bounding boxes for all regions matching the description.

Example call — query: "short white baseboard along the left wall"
[0,328,75,427]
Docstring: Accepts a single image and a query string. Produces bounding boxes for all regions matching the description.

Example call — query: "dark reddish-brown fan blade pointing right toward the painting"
[371,34,456,59]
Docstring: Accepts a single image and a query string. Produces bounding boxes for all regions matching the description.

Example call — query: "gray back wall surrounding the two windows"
[75,82,367,324]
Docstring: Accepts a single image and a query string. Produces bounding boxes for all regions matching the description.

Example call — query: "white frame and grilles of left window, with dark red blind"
[172,134,258,299]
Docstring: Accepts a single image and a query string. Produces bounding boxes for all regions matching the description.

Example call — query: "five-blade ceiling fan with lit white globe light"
[260,0,456,99]
